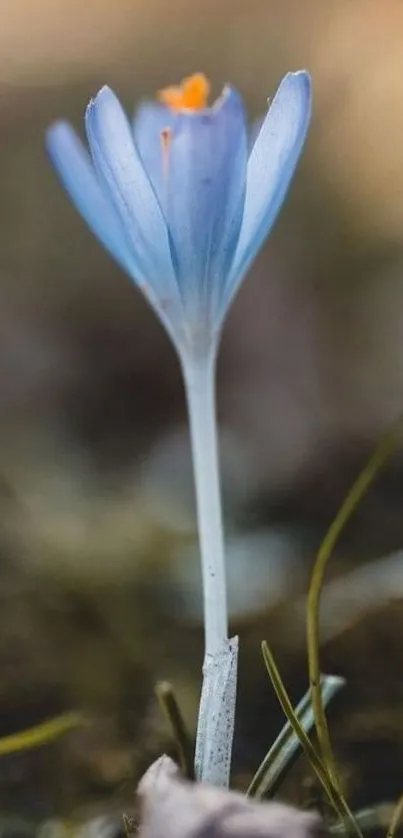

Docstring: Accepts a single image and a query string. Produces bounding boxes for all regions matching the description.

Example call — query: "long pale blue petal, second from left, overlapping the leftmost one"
[86,87,178,308]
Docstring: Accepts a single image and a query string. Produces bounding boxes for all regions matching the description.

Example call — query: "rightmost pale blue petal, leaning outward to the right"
[227,70,311,305]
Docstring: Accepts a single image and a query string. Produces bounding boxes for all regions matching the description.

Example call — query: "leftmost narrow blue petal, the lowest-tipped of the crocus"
[46,122,135,279]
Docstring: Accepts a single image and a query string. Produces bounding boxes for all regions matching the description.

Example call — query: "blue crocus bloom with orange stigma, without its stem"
[47,71,311,358]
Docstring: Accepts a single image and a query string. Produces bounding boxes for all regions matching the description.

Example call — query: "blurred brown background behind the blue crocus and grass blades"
[0,0,403,834]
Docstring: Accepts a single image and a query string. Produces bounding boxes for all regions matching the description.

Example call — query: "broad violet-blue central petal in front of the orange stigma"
[166,88,247,332]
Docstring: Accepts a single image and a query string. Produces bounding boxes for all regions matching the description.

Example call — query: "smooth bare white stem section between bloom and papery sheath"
[183,355,228,654]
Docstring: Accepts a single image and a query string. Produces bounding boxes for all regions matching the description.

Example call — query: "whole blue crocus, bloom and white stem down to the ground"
[48,72,311,786]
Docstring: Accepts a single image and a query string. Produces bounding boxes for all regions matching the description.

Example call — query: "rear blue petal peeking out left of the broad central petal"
[133,102,176,207]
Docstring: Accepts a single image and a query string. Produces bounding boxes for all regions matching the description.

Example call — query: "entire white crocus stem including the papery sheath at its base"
[182,354,238,786]
